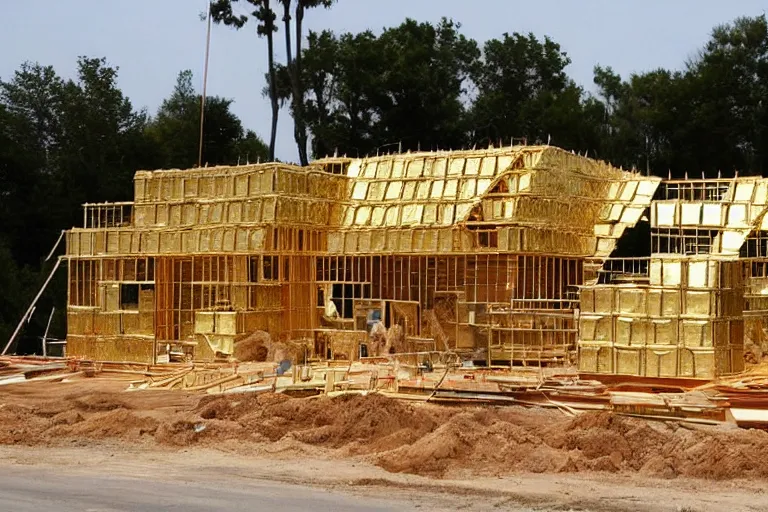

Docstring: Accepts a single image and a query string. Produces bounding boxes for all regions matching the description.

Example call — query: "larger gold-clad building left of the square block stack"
[67,146,658,362]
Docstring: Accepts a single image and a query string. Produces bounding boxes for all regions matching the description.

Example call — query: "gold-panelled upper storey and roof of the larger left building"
[67,146,659,256]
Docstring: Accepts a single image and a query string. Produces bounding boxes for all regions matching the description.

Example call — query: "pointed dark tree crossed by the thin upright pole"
[147,70,268,169]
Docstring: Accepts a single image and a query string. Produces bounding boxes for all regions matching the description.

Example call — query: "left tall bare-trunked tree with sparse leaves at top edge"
[210,0,280,161]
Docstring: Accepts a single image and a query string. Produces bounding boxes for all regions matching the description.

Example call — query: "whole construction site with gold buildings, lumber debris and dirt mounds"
[7,145,768,510]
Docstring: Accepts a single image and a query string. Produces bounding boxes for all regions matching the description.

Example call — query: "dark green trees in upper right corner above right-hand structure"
[595,16,768,177]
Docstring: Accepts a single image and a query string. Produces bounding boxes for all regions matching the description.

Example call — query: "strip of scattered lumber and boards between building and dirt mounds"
[0,353,768,430]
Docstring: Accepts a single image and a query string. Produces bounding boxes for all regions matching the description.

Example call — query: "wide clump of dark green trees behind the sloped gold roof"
[292,19,616,156]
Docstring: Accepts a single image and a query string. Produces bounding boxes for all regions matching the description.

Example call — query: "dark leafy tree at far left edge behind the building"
[0,58,146,266]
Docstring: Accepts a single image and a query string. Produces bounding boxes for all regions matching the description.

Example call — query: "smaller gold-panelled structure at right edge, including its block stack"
[579,178,768,378]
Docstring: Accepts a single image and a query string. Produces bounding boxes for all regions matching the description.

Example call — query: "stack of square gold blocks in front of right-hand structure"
[579,256,744,379]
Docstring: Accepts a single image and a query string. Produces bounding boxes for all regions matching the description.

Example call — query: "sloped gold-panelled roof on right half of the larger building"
[334,146,655,230]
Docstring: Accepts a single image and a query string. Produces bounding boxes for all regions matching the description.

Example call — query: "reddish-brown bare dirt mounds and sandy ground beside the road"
[0,378,768,511]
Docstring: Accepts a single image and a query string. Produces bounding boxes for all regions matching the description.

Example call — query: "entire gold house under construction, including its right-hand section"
[65,146,768,378]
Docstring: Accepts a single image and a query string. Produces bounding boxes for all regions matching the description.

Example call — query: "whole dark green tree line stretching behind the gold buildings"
[0,8,768,352]
